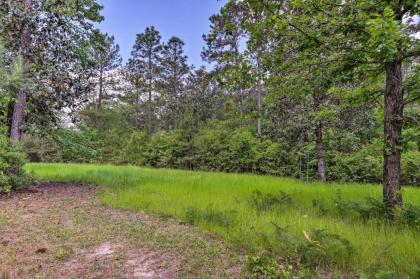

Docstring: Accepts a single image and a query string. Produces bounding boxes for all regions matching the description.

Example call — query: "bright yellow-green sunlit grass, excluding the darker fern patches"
[26,164,420,278]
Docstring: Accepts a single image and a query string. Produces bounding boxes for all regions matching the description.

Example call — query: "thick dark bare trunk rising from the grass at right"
[383,61,404,209]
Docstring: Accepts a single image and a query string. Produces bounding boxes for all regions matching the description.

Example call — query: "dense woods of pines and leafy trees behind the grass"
[0,0,420,207]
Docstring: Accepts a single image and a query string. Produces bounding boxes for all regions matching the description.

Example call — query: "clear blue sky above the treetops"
[98,0,227,66]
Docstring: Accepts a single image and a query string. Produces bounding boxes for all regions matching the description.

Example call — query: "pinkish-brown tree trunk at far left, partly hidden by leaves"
[10,0,31,141]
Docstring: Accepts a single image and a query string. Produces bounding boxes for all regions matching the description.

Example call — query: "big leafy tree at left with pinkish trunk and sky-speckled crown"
[0,0,102,140]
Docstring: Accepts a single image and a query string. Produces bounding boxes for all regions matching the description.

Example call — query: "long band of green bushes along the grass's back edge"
[45,110,420,188]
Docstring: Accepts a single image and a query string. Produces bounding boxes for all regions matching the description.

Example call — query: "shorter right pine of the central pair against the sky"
[159,37,190,129]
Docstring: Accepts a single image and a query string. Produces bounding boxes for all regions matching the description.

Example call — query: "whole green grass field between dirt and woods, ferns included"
[26,164,420,278]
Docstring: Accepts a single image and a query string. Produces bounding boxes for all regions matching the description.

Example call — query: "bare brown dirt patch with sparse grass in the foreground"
[0,184,241,279]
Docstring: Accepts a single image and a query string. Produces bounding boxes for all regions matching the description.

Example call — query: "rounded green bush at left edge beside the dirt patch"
[0,135,31,193]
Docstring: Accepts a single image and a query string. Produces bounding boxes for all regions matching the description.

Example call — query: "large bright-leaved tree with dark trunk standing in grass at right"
[248,0,420,208]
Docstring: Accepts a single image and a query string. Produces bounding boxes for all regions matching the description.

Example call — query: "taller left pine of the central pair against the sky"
[127,26,162,136]
